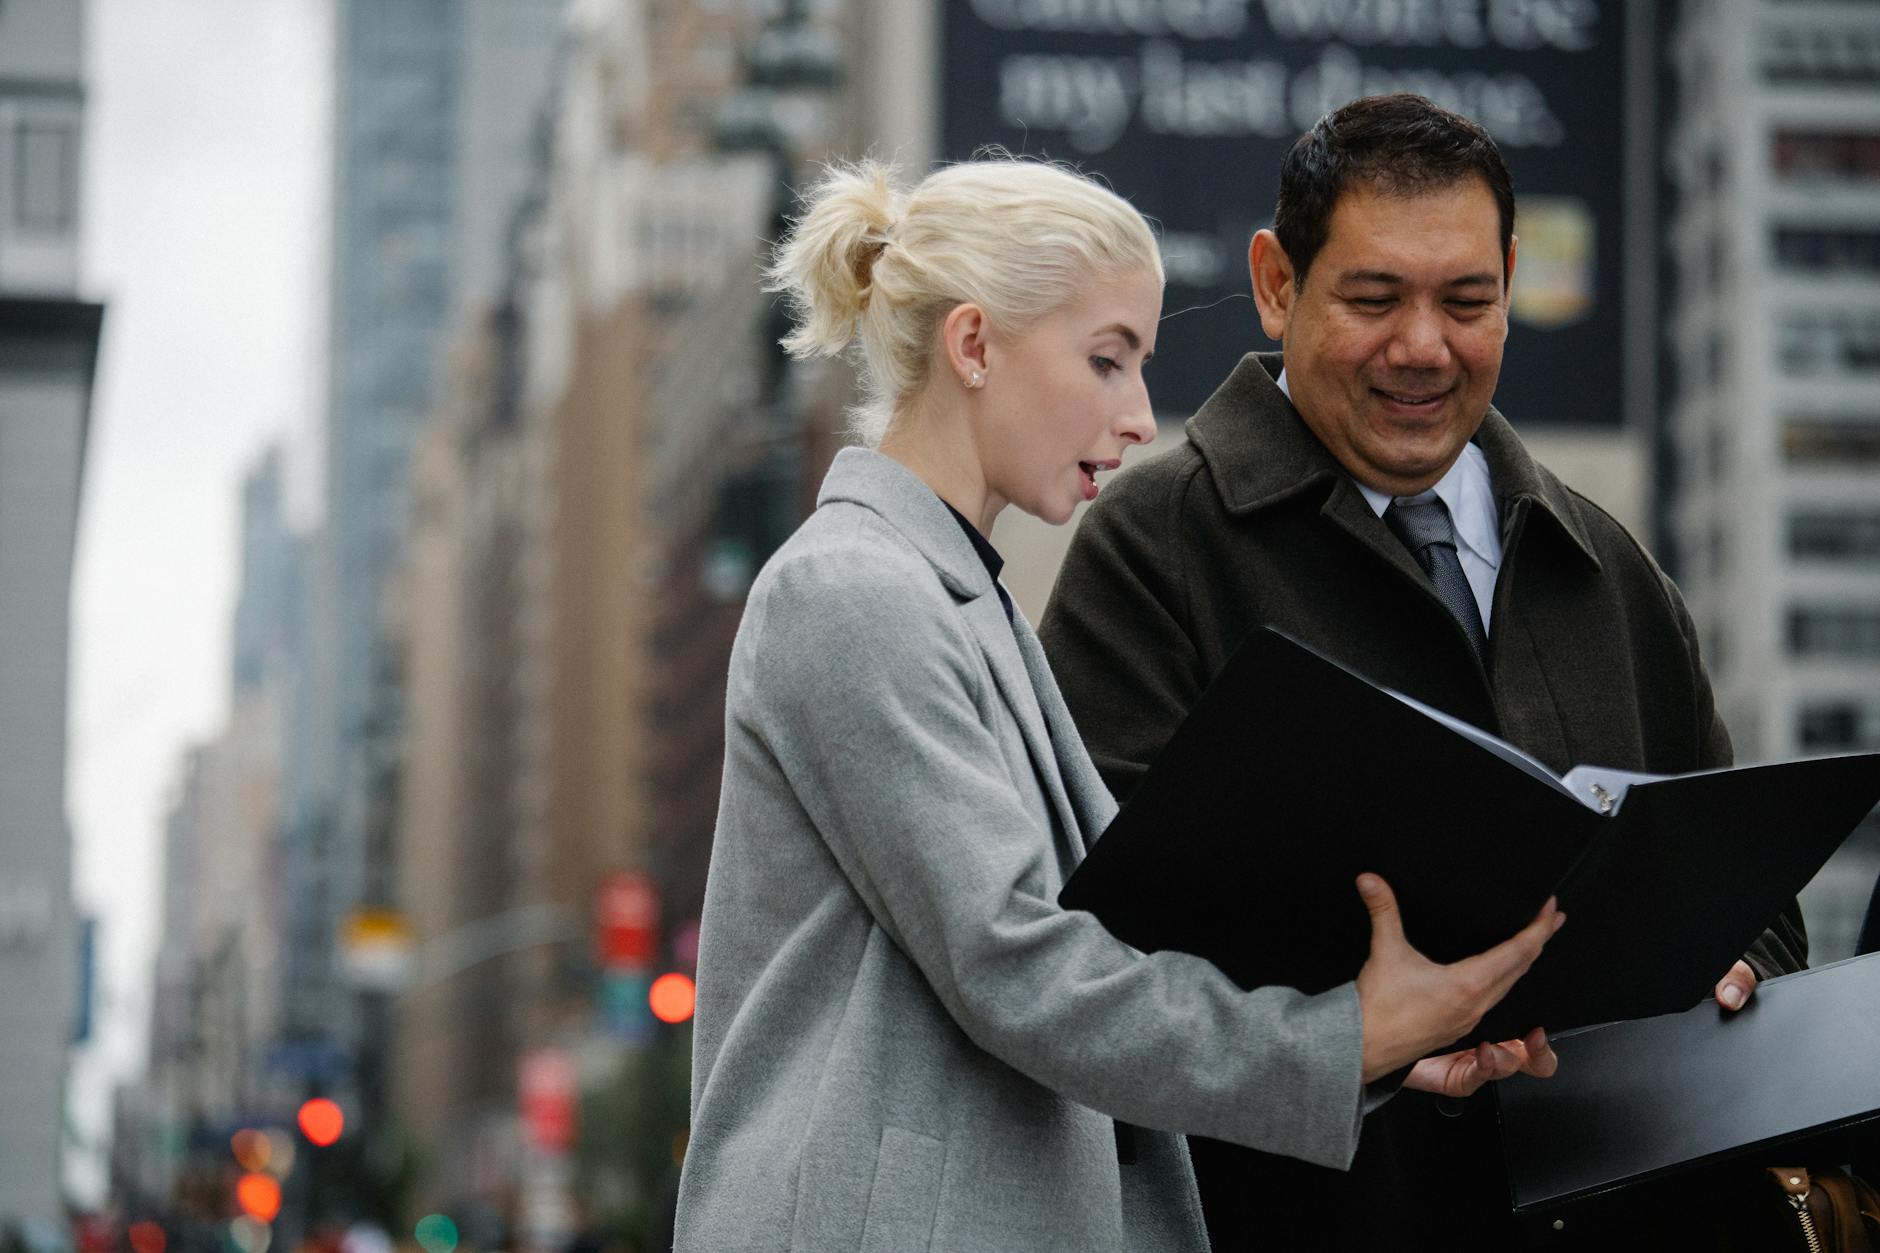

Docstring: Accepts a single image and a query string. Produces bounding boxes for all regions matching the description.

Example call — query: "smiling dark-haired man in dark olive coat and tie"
[1040,94,1807,1253]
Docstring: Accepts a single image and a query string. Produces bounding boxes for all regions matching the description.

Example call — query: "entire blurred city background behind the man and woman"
[0,0,1880,1253]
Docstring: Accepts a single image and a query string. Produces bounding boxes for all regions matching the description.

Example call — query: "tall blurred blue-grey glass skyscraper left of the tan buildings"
[280,0,562,1121]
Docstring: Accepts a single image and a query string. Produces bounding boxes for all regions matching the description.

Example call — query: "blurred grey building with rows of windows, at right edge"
[1658,0,1880,956]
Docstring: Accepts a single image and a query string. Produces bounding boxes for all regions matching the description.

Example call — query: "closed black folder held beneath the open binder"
[1495,954,1880,1247]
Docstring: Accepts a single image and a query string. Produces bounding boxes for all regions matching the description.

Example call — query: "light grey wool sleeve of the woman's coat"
[746,549,1361,1168]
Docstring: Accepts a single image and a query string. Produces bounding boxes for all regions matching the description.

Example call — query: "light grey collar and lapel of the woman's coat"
[816,448,1115,862]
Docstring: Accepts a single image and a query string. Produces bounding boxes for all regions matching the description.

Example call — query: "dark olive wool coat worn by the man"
[1040,354,1807,1251]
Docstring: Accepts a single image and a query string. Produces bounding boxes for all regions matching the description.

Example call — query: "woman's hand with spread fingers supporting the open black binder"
[1357,875,1566,1091]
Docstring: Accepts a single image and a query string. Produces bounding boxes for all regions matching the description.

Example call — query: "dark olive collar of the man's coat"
[1188,352,1600,568]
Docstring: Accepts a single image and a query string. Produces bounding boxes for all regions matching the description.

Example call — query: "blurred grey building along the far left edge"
[0,0,103,1238]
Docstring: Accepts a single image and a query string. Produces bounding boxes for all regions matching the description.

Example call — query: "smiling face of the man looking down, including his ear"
[1248,179,1515,497]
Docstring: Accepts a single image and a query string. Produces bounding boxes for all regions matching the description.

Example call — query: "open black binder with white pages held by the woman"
[1058,628,1880,1039]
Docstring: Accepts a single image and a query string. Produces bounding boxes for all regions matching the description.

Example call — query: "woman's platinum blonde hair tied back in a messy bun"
[765,152,1162,446]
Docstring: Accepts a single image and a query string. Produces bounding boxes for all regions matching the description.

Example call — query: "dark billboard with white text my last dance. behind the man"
[940,0,1651,427]
